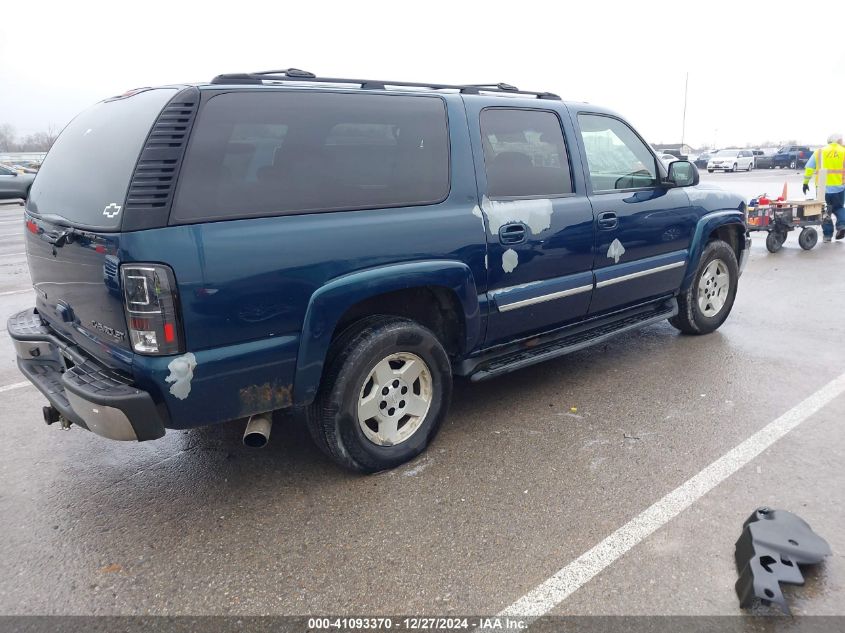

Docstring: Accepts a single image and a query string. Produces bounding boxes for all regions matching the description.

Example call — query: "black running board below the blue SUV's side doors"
[467,299,678,382]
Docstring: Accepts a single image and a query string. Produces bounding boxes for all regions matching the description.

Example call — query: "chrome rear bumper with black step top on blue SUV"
[7,309,165,441]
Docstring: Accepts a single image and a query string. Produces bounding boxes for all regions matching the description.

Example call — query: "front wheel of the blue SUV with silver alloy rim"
[669,240,739,334]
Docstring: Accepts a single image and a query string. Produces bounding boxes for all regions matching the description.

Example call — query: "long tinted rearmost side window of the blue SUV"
[173,92,449,223]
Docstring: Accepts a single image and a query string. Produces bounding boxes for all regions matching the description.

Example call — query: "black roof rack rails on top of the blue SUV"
[211,68,560,101]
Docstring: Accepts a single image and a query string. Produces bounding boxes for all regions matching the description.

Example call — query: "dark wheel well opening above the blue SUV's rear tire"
[332,285,466,358]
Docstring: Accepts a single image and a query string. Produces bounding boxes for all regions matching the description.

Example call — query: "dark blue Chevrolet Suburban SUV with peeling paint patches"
[8,69,750,472]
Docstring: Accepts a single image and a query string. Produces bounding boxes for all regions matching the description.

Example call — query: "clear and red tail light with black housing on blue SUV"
[120,264,184,356]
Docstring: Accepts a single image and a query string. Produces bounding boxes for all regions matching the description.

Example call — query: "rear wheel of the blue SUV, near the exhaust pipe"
[307,316,452,473]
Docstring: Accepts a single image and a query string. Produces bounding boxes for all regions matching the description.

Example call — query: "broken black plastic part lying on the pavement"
[734,508,831,613]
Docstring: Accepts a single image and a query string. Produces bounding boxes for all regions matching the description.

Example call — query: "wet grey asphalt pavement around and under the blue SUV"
[0,170,845,615]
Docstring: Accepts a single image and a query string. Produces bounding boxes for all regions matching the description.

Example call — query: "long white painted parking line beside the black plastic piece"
[499,374,845,617]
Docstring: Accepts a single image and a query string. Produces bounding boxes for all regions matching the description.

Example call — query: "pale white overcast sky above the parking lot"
[0,0,845,146]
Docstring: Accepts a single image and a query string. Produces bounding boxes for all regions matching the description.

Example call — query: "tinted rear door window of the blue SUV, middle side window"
[481,108,572,198]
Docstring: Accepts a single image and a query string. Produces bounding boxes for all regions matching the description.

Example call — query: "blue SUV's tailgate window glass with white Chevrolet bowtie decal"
[27,88,176,230]
